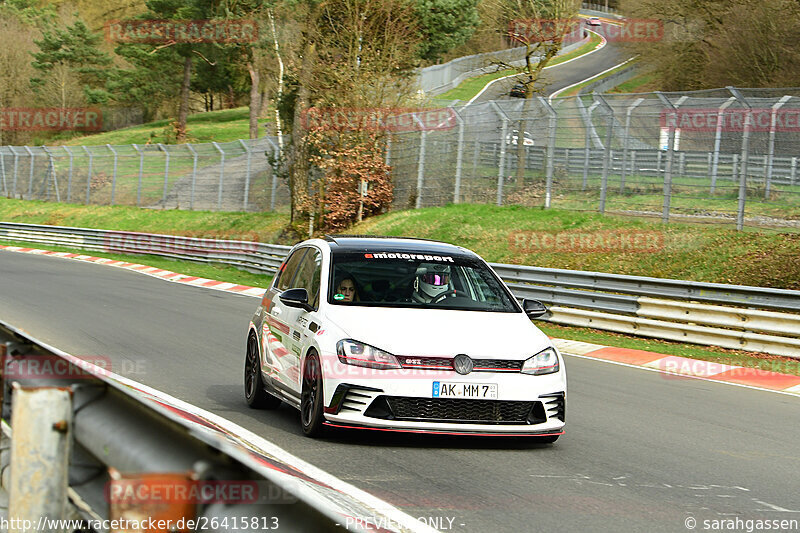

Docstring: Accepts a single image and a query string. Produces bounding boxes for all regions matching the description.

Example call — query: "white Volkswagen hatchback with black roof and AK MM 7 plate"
[244,236,567,442]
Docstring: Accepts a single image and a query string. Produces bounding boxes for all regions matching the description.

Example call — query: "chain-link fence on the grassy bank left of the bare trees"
[0,138,289,211]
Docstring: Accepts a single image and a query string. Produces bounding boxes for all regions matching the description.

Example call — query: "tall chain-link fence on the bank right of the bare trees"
[387,88,800,229]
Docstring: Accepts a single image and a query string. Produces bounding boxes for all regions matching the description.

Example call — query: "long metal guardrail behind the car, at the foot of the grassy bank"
[0,222,800,357]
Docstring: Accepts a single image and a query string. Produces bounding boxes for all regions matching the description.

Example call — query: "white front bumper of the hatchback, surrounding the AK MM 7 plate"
[324,370,566,436]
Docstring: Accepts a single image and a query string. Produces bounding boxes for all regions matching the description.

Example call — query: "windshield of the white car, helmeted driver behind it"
[328,251,520,313]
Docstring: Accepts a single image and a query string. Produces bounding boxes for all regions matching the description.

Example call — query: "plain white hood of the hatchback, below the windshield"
[326,306,552,359]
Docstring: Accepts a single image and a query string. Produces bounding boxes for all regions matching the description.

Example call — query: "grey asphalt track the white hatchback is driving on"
[0,251,800,532]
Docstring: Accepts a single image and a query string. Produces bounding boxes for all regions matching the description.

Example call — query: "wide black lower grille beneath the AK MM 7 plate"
[378,396,537,424]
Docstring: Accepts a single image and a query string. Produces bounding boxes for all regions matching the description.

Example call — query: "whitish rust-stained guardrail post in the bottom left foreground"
[8,383,72,533]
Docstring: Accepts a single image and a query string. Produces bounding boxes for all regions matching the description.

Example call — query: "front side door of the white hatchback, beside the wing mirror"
[284,247,322,395]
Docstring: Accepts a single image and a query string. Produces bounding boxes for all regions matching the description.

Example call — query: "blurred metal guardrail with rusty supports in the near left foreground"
[0,321,433,532]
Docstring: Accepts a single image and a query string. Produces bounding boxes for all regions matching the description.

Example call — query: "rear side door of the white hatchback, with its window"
[262,247,309,393]
